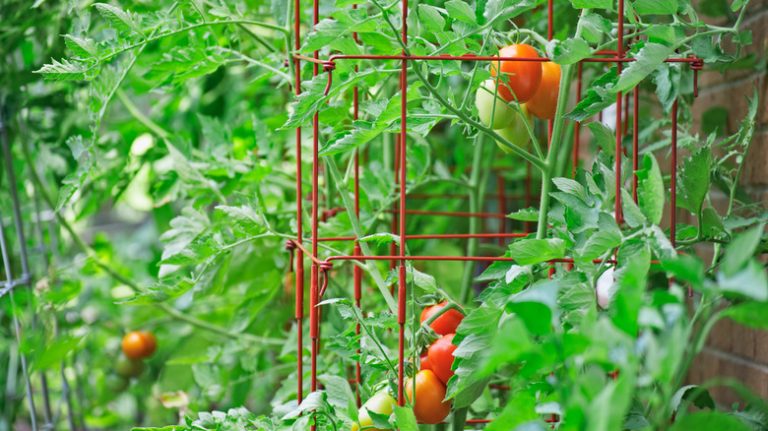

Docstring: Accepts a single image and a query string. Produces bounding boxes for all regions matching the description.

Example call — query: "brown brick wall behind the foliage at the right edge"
[689,0,768,405]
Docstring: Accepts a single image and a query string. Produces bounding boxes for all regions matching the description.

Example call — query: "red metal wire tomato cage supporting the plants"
[286,0,703,424]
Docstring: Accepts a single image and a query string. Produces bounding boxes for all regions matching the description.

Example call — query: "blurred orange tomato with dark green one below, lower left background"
[107,331,157,392]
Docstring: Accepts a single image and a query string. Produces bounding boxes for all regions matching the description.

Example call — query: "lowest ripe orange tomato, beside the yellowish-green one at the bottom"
[405,370,451,424]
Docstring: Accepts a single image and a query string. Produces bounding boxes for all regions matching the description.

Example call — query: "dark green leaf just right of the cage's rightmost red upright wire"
[677,147,712,214]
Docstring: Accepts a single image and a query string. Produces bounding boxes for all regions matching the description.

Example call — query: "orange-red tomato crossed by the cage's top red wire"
[491,43,541,103]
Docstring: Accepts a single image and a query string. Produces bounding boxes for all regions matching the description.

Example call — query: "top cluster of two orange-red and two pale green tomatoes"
[475,43,561,152]
